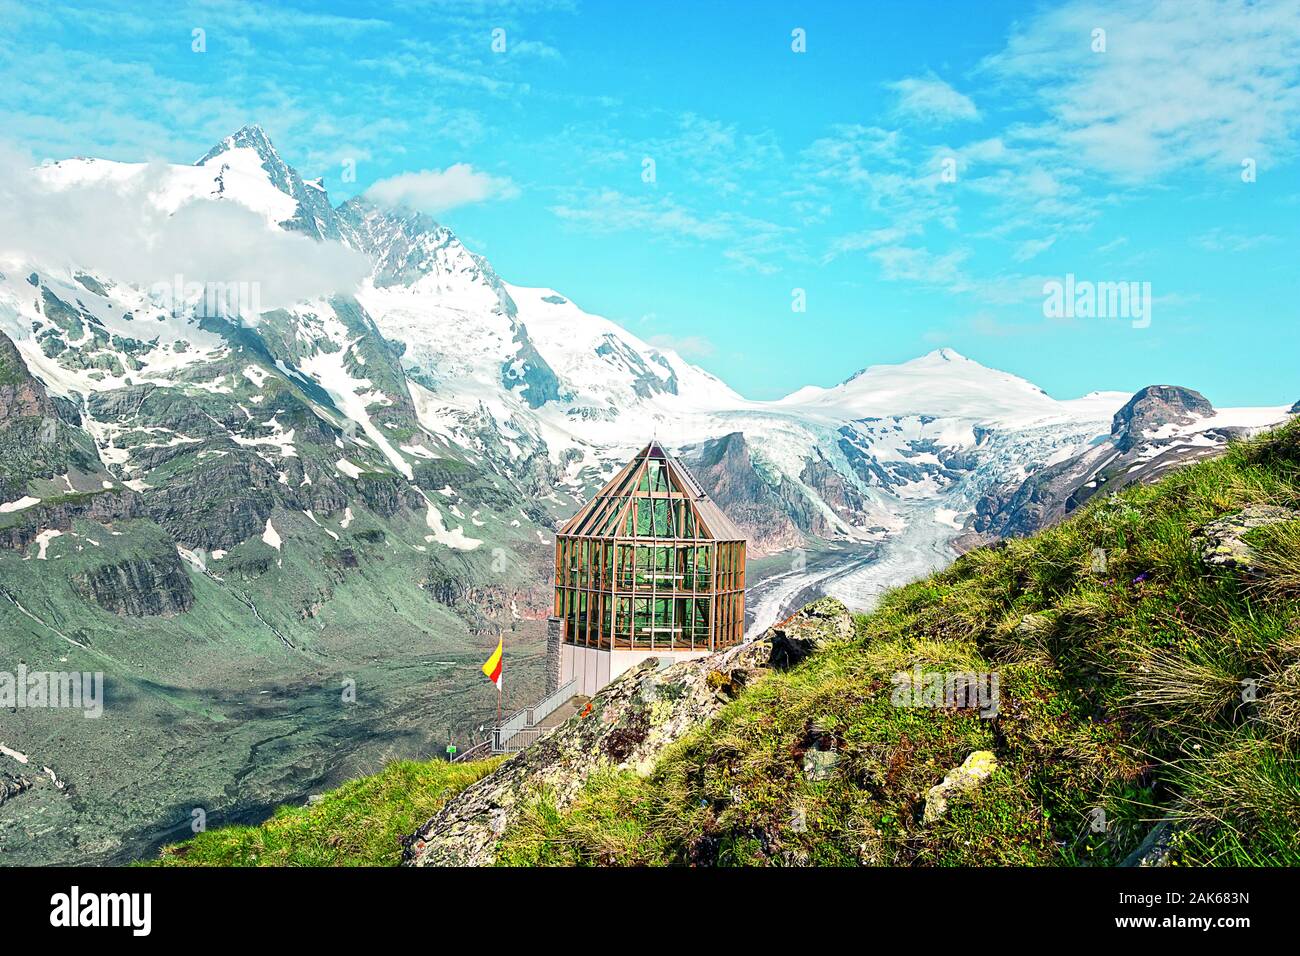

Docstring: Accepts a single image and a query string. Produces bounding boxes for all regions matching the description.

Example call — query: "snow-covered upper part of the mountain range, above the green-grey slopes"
[0,126,1284,613]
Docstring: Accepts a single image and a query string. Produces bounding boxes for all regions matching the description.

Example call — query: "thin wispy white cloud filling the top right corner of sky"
[984,0,1300,181]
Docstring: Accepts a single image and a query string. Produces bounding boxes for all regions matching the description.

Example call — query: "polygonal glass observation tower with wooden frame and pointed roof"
[555,442,745,693]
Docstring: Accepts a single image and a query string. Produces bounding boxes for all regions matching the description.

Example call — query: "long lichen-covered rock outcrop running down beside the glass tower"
[403,598,853,866]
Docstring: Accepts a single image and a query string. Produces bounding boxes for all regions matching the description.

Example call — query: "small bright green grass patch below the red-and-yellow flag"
[151,760,501,866]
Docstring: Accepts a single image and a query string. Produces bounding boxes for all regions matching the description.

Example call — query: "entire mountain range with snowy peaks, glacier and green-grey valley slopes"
[0,126,1294,862]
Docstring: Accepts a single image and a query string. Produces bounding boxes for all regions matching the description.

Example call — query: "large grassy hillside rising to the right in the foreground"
[501,424,1300,865]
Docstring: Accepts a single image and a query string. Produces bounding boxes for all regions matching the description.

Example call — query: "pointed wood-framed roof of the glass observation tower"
[559,441,745,541]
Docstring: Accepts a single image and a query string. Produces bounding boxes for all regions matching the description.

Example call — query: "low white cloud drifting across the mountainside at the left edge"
[0,143,371,310]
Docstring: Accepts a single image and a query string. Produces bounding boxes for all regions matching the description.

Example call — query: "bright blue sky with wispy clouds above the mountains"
[0,0,1300,405]
